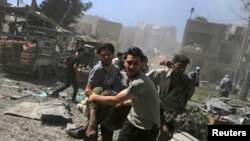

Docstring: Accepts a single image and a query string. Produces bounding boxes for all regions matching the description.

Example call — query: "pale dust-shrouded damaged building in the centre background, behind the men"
[122,22,179,58]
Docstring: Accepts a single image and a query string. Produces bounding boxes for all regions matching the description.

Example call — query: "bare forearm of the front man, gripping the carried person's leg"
[88,89,132,105]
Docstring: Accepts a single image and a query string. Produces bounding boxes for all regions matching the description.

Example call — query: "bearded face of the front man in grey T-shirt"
[124,54,141,78]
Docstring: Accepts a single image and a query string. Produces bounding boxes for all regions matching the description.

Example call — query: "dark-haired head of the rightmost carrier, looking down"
[172,54,190,74]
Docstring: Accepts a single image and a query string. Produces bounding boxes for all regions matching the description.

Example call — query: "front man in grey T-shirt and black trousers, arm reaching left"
[89,47,160,141]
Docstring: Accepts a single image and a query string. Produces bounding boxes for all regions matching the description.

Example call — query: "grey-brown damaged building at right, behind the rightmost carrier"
[181,17,244,82]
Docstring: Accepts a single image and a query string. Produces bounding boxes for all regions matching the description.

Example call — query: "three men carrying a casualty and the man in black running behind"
[54,43,201,141]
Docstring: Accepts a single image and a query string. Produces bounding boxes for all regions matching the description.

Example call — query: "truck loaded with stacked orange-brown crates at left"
[0,5,63,79]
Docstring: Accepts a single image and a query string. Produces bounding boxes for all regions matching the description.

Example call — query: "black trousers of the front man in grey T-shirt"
[118,119,159,141]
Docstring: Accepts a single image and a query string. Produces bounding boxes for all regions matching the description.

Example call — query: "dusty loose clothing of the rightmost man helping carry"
[147,69,195,141]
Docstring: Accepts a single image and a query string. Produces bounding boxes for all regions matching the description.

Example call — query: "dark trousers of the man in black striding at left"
[55,76,78,101]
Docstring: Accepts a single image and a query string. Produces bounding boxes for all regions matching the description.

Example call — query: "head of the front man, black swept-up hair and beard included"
[124,47,145,78]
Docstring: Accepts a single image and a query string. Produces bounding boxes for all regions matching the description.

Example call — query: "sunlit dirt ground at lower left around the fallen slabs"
[0,66,93,141]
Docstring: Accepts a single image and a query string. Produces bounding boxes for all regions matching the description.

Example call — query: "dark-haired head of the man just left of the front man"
[97,43,115,66]
